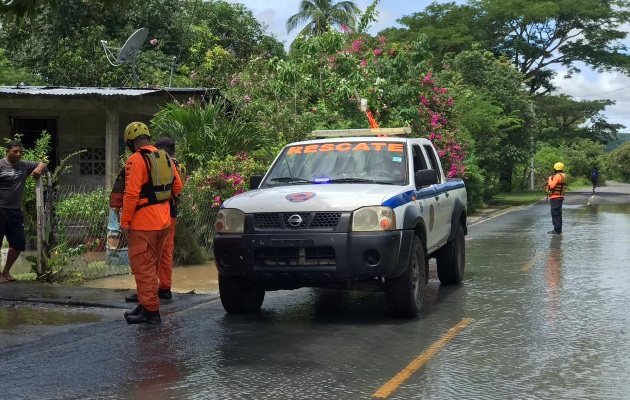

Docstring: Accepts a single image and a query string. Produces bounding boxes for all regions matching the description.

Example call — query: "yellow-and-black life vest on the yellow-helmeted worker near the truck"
[109,149,175,210]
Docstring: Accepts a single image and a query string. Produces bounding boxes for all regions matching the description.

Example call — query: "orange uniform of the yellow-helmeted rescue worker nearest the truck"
[120,145,182,311]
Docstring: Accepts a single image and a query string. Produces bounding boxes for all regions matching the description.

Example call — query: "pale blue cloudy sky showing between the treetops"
[228,0,630,132]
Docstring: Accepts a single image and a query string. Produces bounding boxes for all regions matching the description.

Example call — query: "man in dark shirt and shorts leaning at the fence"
[0,140,46,283]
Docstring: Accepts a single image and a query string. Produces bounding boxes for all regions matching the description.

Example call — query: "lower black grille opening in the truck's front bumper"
[255,246,336,267]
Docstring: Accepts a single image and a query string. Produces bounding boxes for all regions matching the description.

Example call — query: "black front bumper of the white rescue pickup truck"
[213,230,414,288]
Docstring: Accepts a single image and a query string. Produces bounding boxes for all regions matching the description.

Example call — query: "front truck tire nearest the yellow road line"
[385,236,428,318]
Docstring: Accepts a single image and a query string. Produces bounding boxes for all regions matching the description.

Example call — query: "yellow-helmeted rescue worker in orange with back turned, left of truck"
[120,122,182,324]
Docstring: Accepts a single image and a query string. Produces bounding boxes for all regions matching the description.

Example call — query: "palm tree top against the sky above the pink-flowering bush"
[287,0,361,36]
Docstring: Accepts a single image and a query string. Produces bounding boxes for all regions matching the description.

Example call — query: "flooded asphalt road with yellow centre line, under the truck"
[0,185,630,400]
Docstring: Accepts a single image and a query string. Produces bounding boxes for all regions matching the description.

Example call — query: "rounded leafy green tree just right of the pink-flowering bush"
[442,50,536,191]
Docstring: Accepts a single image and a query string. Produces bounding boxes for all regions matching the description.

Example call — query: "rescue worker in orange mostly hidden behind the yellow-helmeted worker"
[155,137,186,300]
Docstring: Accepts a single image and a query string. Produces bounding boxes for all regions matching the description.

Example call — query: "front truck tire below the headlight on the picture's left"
[219,274,265,314]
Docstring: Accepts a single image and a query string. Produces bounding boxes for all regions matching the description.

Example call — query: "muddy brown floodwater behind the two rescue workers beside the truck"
[83,261,219,294]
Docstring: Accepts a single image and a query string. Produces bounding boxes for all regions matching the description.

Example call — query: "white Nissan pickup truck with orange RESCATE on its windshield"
[213,128,468,317]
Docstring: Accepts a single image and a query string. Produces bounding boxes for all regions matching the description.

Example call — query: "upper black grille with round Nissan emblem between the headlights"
[254,212,341,230]
